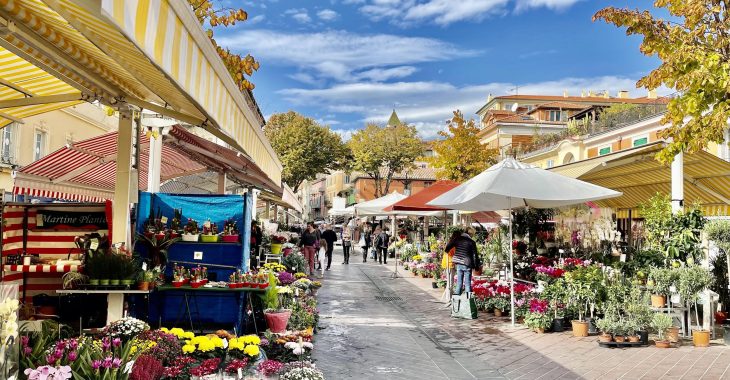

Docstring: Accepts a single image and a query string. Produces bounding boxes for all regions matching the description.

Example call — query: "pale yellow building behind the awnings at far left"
[0,103,119,196]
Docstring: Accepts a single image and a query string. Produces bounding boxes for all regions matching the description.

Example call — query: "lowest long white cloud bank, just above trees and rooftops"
[279,76,671,138]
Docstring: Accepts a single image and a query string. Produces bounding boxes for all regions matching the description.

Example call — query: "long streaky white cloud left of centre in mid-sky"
[219,30,478,82]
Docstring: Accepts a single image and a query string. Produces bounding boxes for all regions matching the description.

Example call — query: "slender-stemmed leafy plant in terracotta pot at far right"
[678,265,712,347]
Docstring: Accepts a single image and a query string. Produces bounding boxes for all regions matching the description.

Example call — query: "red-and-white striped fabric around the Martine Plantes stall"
[2,205,107,302]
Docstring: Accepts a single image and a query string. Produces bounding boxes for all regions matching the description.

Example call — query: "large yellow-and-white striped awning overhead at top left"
[0,0,282,184]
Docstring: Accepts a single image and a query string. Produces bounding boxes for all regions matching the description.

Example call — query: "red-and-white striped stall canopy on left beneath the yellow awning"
[13,126,282,201]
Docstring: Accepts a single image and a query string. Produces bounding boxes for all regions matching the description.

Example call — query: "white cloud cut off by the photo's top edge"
[353,0,582,26]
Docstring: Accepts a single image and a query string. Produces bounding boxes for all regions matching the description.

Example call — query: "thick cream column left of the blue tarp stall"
[112,109,137,247]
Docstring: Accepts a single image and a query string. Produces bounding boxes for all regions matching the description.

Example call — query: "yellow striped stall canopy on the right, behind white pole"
[550,142,730,216]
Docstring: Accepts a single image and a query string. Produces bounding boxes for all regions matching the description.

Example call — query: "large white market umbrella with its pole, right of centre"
[427,157,622,325]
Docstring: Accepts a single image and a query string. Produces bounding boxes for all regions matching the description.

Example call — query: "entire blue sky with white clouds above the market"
[216,0,658,138]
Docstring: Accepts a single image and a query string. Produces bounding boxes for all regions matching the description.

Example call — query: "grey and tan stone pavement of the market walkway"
[315,248,730,380]
